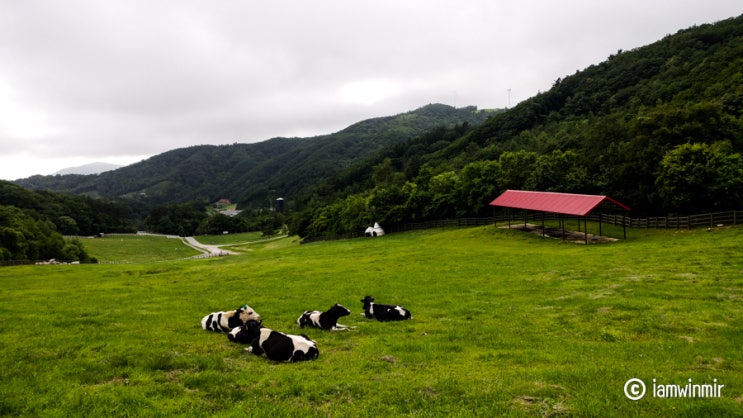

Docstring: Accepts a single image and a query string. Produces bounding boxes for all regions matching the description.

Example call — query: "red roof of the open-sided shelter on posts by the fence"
[490,190,630,216]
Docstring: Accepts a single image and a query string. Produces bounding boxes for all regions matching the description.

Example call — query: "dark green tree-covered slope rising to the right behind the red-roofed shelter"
[295,16,743,236]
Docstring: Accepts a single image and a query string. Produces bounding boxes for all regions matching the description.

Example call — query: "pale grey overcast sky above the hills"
[0,0,743,180]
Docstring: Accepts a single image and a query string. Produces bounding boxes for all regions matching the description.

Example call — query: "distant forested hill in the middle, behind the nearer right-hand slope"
[14,104,497,207]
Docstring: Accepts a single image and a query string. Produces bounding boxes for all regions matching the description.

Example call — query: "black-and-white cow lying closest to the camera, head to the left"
[227,321,320,363]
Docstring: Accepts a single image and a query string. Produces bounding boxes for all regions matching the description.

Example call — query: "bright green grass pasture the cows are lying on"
[0,226,743,417]
